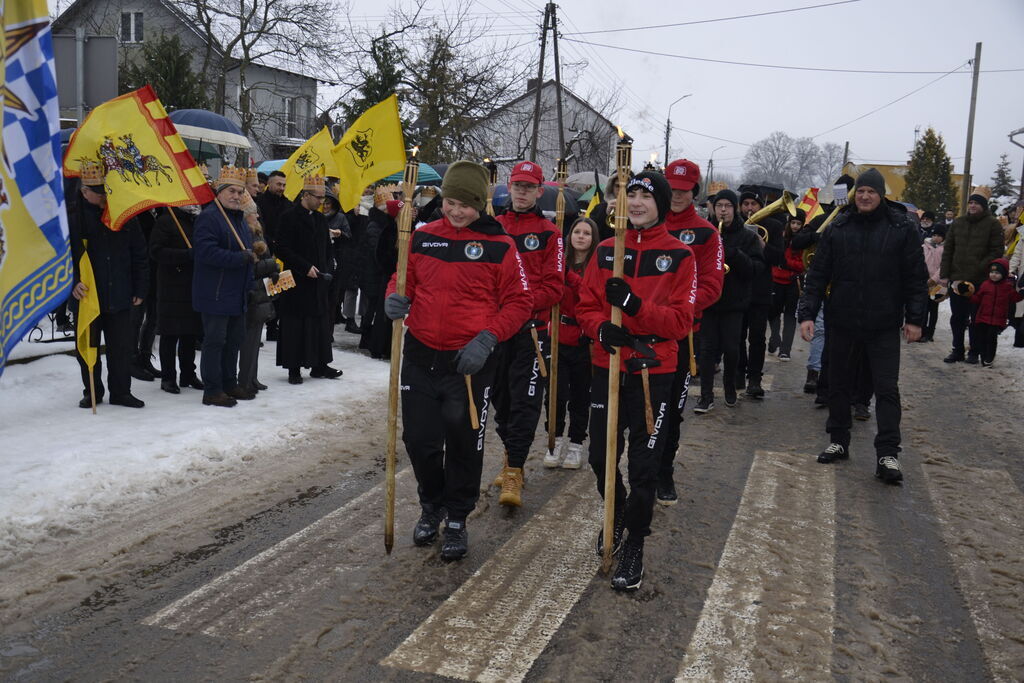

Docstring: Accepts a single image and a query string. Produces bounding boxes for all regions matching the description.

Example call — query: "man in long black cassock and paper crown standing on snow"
[274,176,342,384]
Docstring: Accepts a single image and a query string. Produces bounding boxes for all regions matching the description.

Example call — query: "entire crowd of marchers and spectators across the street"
[61,152,1024,590]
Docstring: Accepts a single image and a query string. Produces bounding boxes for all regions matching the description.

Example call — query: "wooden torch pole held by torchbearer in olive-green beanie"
[384,150,420,555]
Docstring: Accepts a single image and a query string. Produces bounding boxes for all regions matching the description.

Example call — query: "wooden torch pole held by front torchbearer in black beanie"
[601,129,633,573]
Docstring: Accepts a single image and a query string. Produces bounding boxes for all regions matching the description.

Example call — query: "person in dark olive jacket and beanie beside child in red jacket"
[939,185,1004,365]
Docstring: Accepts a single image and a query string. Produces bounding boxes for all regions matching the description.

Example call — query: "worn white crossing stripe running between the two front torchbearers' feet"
[381,472,603,681]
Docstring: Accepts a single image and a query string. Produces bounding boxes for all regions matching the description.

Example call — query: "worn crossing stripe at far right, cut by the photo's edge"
[922,464,1024,681]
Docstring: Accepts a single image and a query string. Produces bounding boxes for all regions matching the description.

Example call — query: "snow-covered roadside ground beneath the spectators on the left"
[0,343,388,566]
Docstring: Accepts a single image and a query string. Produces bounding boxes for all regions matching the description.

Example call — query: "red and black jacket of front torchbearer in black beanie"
[577,223,697,375]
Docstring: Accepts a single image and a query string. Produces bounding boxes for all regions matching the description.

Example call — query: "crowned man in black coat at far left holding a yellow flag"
[68,164,150,408]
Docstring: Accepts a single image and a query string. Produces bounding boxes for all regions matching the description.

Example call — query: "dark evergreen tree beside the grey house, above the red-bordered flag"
[118,34,210,112]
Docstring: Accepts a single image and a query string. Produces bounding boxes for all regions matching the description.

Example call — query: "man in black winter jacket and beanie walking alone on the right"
[798,169,928,483]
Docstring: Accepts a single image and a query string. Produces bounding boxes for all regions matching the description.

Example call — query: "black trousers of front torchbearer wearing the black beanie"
[590,366,672,539]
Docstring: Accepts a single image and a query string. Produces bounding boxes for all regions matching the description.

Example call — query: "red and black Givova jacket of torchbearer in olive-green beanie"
[387,216,534,351]
